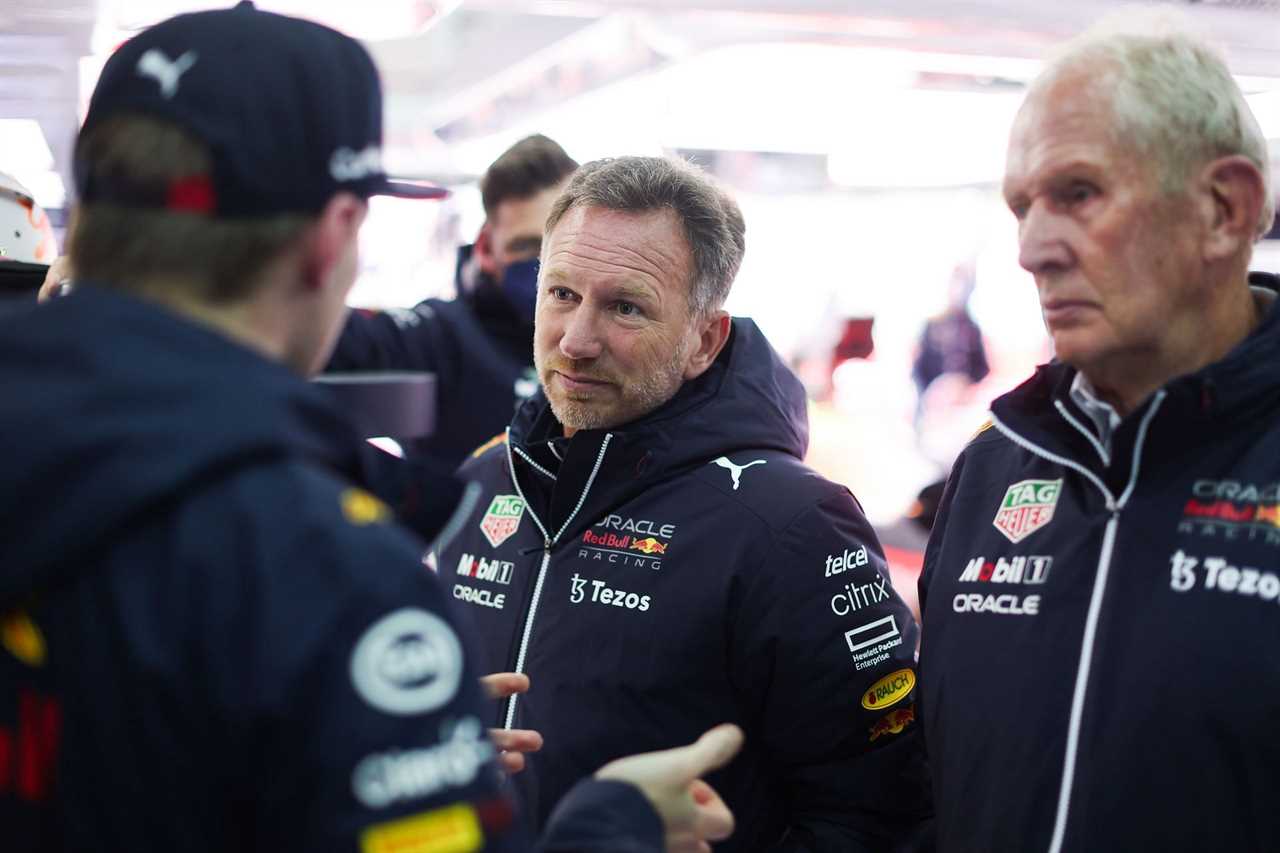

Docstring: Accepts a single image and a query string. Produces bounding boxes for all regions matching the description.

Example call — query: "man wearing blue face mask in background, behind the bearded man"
[326,136,577,471]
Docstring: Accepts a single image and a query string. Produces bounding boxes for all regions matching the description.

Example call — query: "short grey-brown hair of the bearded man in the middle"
[547,156,746,316]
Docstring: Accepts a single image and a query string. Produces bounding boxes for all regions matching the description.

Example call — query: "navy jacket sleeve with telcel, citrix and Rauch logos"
[731,491,932,853]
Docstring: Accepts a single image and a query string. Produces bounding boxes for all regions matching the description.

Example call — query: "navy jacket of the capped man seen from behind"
[0,284,662,853]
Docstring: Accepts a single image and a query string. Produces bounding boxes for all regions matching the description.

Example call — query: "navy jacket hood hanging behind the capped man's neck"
[0,286,371,608]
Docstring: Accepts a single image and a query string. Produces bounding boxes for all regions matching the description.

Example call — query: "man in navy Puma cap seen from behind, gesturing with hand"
[0,4,741,853]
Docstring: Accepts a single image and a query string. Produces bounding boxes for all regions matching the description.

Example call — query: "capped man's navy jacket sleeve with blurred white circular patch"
[205,471,662,853]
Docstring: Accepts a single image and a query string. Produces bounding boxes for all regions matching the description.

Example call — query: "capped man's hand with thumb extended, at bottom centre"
[595,724,742,853]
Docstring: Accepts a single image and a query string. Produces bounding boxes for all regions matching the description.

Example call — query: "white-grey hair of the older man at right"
[1032,10,1275,237]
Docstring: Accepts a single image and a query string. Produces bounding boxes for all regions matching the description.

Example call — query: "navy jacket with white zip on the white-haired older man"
[919,275,1280,853]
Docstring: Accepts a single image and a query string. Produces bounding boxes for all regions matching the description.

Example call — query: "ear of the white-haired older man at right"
[1198,154,1266,261]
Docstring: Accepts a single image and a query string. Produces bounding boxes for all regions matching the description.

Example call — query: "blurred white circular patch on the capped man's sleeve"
[351,607,462,715]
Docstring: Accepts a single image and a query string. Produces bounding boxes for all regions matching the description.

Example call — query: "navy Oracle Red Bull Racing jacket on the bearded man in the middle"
[438,319,928,850]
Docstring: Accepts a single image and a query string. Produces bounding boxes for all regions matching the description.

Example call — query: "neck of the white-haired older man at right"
[1079,274,1263,418]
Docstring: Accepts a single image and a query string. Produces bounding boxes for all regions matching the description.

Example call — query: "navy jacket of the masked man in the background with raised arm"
[325,246,538,471]
